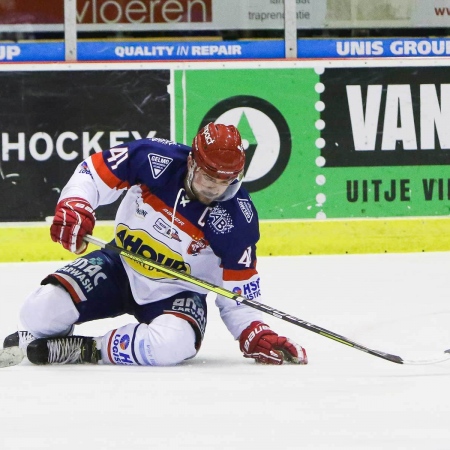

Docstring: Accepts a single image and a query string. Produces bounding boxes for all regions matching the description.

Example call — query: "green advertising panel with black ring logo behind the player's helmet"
[171,68,321,219]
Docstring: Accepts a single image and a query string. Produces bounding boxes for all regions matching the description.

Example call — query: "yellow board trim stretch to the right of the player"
[258,217,450,256]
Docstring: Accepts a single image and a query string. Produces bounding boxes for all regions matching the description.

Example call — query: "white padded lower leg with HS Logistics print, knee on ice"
[101,314,196,366]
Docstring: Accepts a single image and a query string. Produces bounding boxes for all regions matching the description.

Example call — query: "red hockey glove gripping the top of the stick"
[50,197,95,254]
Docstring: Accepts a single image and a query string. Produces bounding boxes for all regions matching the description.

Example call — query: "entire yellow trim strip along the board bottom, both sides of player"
[0,217,450,262]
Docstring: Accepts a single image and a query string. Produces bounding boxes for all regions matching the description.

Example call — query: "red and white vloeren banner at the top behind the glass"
[0,0,327,33]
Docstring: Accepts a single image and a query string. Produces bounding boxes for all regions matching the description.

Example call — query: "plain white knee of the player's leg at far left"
[20,284,79,338]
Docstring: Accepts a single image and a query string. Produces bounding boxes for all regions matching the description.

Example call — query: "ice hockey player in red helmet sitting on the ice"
[2,123,307,366]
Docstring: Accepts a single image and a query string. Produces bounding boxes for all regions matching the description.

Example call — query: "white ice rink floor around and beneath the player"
[0,253,450,450]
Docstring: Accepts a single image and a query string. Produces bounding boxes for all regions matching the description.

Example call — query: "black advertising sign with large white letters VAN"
[321,67,450,167]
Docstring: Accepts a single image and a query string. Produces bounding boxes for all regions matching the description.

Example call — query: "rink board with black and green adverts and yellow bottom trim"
[0,58,450,261]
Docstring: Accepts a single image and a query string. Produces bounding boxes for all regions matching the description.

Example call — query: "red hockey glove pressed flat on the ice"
[239,321,308,364]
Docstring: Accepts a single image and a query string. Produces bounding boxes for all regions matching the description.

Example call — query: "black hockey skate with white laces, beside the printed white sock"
[27,336,101,364]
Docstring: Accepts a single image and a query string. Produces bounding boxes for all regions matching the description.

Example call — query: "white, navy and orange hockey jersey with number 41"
[60,138,262,339]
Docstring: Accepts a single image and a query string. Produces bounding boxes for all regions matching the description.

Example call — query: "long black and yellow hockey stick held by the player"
[84,235,450,365]
